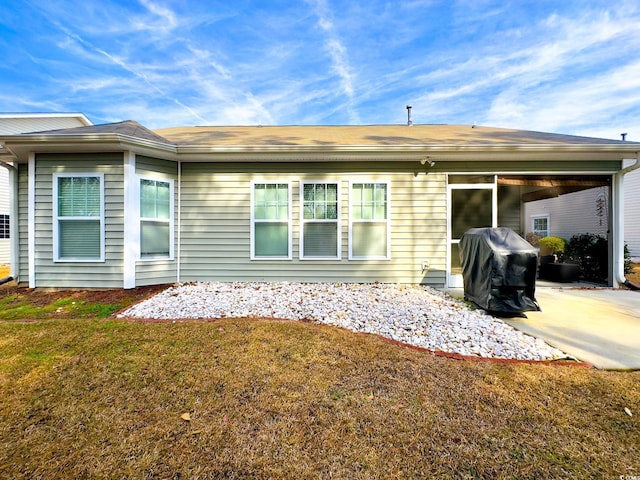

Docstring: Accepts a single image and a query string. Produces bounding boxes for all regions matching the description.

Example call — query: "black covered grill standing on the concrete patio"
[460,227,540,313]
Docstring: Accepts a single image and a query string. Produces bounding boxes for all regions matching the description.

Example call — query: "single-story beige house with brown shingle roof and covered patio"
[0,121,640,288]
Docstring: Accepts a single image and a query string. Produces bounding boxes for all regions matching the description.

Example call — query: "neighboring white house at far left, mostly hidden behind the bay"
[0,113,92,264]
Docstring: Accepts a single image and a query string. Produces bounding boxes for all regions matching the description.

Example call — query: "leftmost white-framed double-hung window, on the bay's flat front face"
[53,173,104,262]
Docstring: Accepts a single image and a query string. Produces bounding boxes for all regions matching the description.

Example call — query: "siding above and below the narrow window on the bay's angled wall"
[136,155,178,286]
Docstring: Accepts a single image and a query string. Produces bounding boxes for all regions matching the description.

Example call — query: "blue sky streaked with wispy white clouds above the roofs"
[0,0,640,140]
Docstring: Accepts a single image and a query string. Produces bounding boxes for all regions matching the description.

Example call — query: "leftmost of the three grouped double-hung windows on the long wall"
[251,182,291,260]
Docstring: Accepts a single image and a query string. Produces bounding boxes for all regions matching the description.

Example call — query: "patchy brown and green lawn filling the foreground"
[0,288,640,479]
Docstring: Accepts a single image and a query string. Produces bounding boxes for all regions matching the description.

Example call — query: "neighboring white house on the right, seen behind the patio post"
[524,170,640,261]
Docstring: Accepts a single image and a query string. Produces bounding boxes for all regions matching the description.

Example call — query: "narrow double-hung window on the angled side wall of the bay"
[140,178,174,259]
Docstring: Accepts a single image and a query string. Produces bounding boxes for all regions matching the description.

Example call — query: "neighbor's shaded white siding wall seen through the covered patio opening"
[524,187,609,240]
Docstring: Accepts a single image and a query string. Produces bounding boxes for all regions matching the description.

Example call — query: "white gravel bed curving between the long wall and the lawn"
[118,282,571,360]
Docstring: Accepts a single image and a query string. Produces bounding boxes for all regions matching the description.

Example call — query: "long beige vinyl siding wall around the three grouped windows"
[181,163,447,285]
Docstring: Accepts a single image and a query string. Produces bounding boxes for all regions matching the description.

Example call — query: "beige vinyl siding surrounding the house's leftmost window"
[35,153,124,288]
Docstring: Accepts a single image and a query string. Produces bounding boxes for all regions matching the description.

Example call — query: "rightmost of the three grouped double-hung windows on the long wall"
[349,182,391,260]
